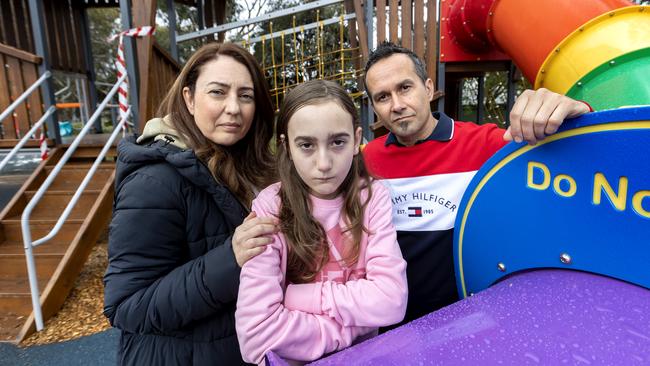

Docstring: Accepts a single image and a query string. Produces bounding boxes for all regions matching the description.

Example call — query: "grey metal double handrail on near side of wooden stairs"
[20,74,131,331]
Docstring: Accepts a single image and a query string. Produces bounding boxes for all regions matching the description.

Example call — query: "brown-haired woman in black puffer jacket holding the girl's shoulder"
[104,43,277,365]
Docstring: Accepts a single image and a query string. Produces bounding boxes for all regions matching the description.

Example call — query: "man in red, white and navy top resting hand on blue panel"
[363,42,590,322]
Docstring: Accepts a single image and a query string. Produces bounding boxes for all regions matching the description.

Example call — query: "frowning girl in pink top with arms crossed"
[235,80,407,364]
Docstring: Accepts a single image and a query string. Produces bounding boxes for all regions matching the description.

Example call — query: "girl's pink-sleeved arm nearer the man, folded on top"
[284,182,408,327]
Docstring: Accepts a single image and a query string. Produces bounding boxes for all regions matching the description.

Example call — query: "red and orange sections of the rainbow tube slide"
[440,0,633,82]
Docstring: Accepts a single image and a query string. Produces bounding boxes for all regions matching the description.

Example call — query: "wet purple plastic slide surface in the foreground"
[267,269,650,365]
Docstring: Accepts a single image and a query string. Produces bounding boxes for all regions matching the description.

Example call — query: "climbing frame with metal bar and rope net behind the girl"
[176,0,363,119]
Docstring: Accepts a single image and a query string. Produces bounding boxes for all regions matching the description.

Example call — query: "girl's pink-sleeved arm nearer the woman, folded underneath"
[235,192,370,364]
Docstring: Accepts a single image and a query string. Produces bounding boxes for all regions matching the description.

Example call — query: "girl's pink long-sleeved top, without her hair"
[235,182,407,364]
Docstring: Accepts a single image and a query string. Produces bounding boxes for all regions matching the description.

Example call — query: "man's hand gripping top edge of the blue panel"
[503,88,590,145]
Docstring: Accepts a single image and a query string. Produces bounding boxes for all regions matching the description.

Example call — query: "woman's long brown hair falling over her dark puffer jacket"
[158,43,275,208]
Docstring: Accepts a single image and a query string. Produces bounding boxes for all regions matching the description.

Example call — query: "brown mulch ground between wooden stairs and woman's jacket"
[20,233,111,347]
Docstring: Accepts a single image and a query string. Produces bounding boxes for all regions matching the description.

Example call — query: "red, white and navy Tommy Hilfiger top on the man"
[363,113,505,321]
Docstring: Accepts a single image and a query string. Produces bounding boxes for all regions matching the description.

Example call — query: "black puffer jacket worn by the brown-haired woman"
[104,119,246,365]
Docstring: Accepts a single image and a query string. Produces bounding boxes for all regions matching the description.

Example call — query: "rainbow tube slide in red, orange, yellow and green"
[449,0,650,110]
